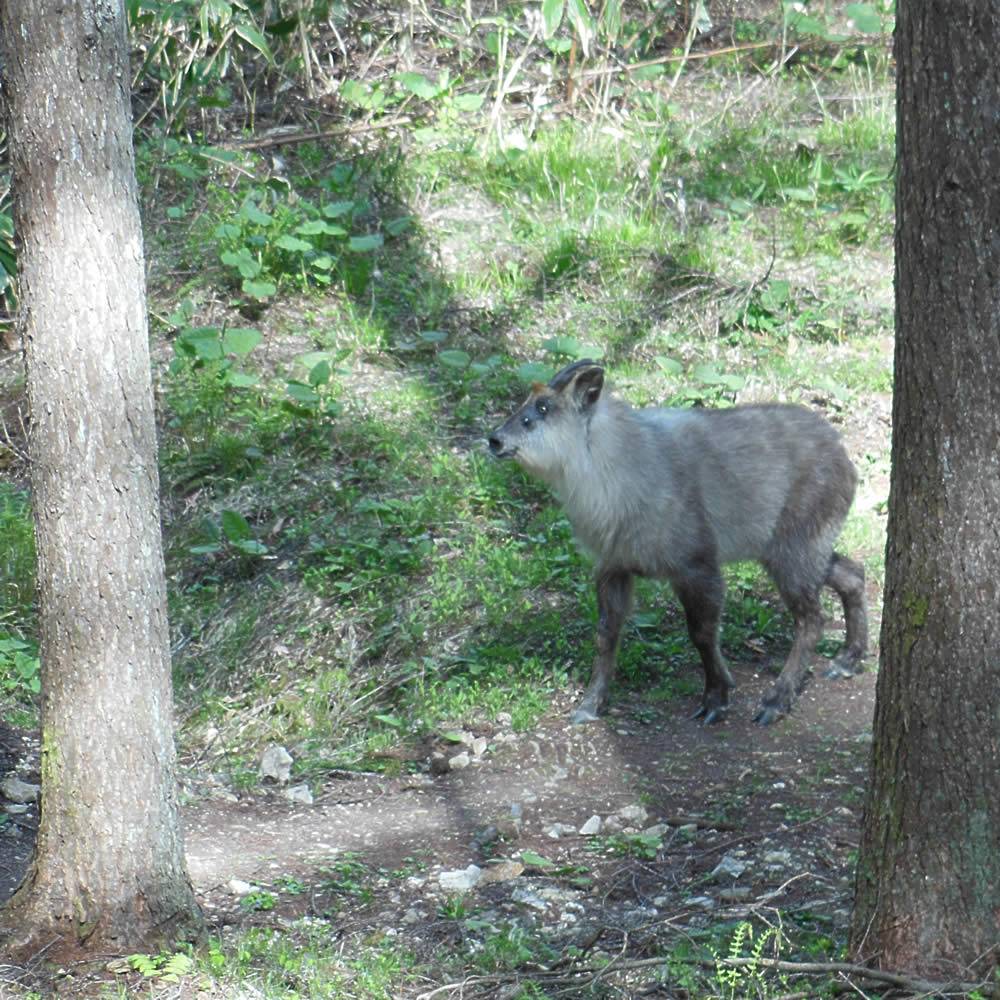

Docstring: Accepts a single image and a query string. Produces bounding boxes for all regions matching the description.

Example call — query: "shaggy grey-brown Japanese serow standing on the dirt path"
[489,360,868,725]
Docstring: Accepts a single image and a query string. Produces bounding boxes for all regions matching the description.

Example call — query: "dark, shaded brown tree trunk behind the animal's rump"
[851,0,1000,978]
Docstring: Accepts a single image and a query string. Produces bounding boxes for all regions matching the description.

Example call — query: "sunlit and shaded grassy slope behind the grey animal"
[154,65,891,773]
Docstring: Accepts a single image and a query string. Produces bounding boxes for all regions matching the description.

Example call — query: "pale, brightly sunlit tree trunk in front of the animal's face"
[0,0,201,953]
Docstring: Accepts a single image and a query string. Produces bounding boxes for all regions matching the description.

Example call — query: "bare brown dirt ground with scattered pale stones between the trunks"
[0,648,875,995]
